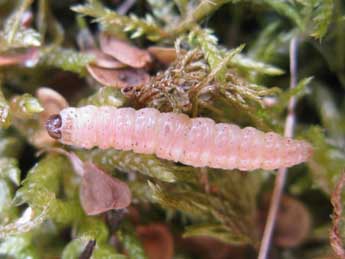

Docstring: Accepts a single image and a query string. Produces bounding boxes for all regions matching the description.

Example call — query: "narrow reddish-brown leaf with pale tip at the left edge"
[0,48,39,67]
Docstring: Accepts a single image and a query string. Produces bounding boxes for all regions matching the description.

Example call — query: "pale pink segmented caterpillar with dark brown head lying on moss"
[46,106,312,171]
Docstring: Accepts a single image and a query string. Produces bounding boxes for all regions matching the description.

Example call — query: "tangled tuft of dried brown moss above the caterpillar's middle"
[134,51,207,113]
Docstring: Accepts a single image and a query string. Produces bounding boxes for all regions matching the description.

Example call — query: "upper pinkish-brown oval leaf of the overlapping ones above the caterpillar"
[100,34,152,68]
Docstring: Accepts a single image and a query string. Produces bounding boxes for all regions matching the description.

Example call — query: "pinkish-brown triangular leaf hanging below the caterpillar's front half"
[80,162,132,215]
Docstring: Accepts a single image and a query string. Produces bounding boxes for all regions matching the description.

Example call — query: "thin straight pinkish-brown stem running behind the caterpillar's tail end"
[258,37,298,259]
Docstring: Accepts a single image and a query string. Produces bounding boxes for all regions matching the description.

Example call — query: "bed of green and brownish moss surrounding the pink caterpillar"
[0,0,345,259]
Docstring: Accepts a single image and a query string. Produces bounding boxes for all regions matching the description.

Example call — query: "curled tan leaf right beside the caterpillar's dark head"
[32,87,68,147]
